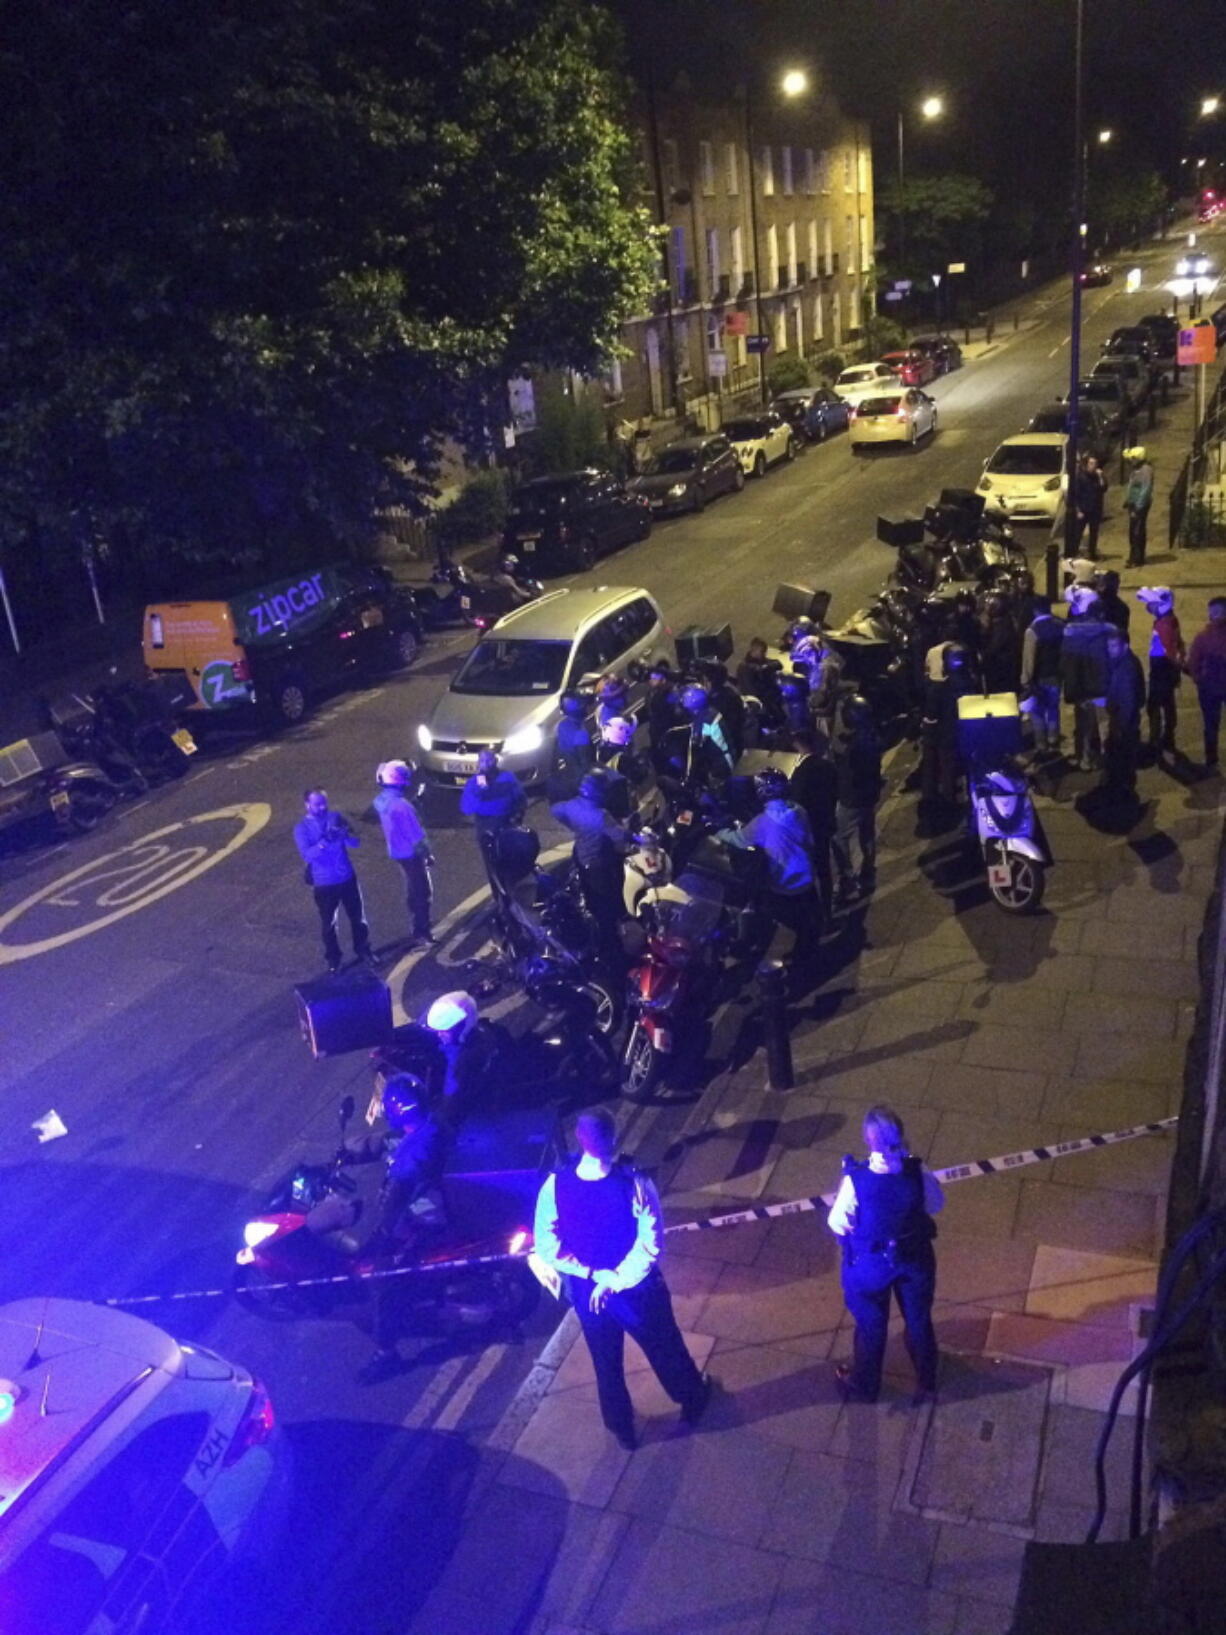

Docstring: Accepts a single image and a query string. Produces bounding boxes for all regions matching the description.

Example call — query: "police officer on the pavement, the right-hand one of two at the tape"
[827,1105,945,1406]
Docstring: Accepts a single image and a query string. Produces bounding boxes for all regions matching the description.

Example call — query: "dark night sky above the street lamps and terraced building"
[615,0,1226,199]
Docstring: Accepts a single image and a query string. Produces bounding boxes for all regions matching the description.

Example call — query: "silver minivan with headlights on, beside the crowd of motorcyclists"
[417,585,670,788]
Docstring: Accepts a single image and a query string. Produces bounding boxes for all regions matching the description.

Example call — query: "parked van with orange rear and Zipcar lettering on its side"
[142,562,422,726]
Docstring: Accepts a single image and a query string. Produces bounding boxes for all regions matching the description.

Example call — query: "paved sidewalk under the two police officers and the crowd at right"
[398,354,1226,1635]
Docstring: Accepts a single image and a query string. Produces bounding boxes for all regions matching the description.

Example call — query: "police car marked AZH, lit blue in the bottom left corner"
[0,1297,288,1635]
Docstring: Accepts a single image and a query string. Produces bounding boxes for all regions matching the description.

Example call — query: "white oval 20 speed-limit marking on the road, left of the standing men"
[0,801,273,965]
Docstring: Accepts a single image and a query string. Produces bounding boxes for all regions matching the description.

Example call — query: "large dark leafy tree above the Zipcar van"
[0,0,656,588]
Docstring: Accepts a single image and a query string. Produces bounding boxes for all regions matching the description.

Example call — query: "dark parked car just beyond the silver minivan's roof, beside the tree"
[502,469,652,574]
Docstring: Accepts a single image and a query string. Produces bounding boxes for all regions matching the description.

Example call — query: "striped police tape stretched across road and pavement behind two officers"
[98,1117,1179,1306]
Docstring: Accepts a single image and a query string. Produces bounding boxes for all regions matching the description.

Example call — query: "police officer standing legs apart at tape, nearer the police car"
[535,1109,713,1449]
